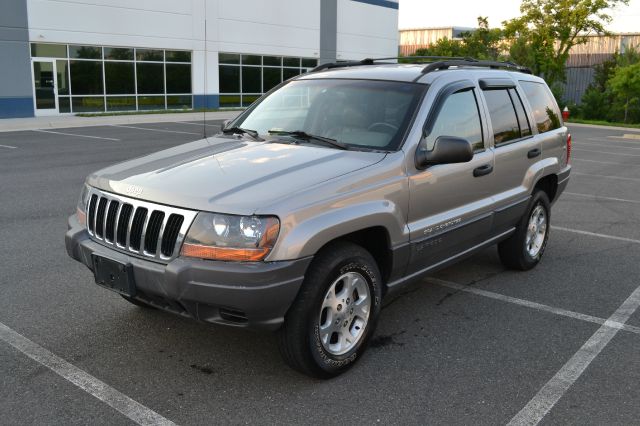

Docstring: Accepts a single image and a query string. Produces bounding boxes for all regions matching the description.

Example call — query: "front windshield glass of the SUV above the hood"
[230,79,426,151]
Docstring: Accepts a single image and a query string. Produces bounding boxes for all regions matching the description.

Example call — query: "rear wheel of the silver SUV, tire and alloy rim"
[498,190,551,271]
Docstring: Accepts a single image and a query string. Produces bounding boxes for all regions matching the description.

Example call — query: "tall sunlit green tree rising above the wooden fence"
[503,0,629,86]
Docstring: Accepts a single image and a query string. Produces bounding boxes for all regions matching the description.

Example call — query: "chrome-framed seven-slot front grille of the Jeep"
[87,190,196,261]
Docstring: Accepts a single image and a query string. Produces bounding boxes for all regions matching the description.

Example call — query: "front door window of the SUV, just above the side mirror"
[427,90,484,151]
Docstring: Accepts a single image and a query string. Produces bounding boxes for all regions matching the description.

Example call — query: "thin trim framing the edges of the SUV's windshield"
[227,78,430,152]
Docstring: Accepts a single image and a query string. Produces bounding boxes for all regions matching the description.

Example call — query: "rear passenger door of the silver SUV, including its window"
[480,78,542,234]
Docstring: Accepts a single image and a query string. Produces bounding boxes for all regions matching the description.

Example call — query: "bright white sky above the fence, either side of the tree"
[398,0,640,32]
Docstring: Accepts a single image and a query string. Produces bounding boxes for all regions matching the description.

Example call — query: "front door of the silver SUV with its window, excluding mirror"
[408,80,493,274]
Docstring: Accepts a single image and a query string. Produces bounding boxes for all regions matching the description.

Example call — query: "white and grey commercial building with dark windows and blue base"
[0,0,398,118]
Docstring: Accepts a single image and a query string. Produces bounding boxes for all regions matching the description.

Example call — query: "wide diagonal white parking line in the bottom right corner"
[509,287,640,426]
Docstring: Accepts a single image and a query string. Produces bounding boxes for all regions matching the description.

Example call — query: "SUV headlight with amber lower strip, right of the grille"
[180,213,280,262]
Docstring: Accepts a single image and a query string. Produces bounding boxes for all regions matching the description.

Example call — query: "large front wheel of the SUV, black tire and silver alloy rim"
[278,242,382,379]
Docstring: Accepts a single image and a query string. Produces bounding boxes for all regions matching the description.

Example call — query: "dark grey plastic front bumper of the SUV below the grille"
[65,215,312,330]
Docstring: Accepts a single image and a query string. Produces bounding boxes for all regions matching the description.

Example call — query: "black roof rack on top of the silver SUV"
[311,56,532,74]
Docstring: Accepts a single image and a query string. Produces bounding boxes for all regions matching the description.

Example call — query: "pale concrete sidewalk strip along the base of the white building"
[0,111,242,132]
